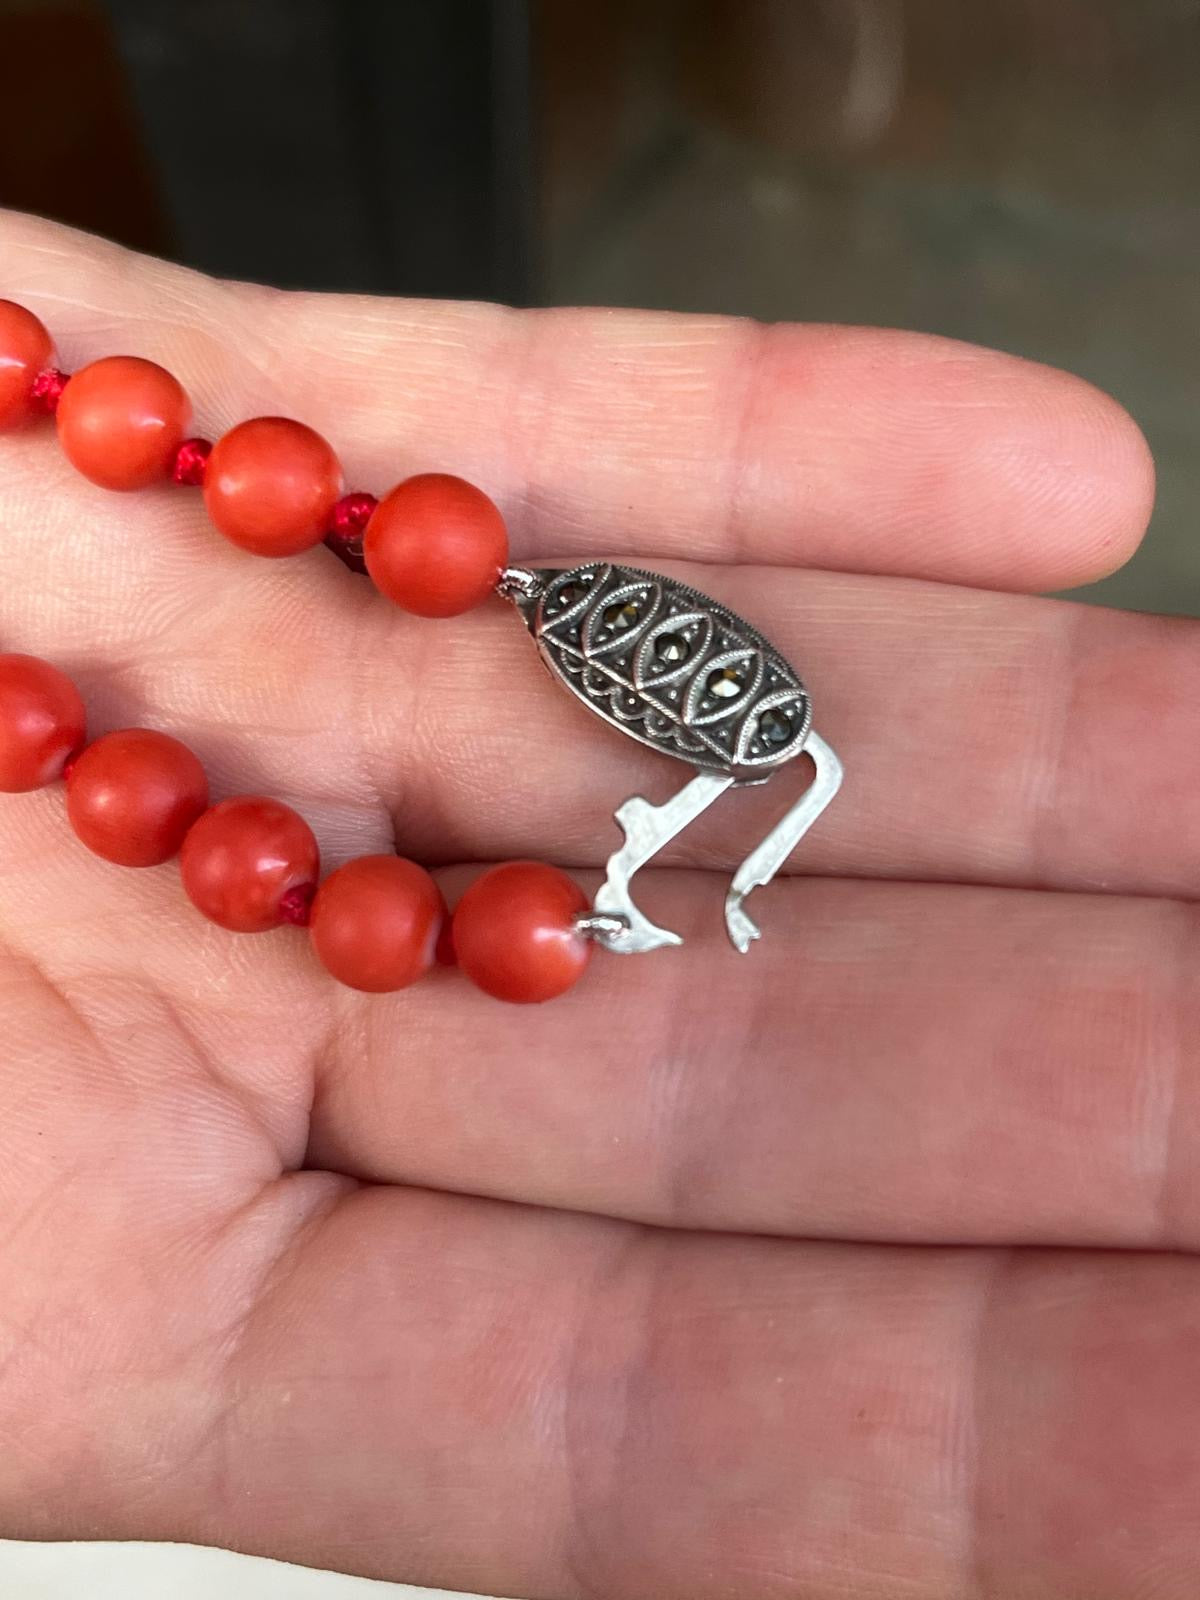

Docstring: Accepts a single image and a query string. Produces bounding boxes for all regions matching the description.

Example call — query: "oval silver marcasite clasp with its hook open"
[498,562,842,955]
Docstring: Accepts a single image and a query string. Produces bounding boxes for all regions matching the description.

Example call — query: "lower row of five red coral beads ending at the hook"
[0,654,590,1003]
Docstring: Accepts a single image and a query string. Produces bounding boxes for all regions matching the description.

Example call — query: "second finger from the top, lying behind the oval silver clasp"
[340,568,1200,896]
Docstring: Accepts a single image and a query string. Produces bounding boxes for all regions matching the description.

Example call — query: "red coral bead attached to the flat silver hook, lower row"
[451,861,592,1005]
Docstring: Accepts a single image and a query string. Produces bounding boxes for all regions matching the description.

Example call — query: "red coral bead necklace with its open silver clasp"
[0,301,842,1002]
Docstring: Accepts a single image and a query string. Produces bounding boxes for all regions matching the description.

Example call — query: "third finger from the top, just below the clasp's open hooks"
[309,874,1200,1248]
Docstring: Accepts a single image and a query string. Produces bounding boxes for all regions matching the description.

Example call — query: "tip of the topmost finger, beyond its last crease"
[720,326,1154,592]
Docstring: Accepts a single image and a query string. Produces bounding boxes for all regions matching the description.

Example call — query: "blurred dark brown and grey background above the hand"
[0,0,1200,614]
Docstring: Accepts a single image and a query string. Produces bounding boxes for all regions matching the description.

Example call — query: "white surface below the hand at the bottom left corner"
[0,1539,502,1600]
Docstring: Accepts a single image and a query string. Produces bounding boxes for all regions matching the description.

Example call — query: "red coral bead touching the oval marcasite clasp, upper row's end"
[363,472,509,616]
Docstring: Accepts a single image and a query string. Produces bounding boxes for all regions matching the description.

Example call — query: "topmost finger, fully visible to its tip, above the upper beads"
[0,214,1152,589]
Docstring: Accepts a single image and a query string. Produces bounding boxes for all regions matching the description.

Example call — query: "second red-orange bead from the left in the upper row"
[56,355,192,490]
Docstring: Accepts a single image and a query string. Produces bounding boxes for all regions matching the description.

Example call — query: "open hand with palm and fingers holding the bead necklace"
[0,216,1200,1600]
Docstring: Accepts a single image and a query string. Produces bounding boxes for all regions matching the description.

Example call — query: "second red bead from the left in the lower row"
[67,728,208,867]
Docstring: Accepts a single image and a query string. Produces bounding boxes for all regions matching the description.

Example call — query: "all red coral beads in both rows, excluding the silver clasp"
[0,301,590,1002]
